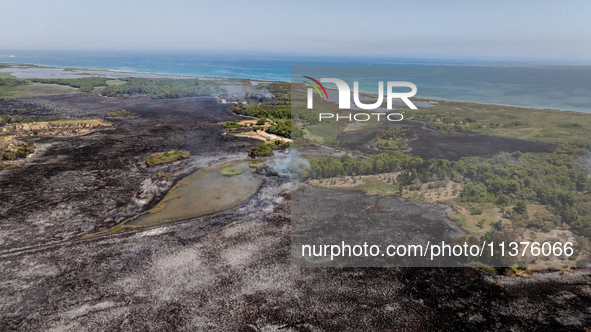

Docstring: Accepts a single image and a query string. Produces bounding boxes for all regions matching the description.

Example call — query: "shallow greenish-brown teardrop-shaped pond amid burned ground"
[122,161,261,228]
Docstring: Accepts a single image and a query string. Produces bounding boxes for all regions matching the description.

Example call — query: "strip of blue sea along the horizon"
[0,50,591,113]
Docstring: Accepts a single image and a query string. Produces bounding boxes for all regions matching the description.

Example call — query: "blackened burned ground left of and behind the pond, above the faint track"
[0,94,258,251]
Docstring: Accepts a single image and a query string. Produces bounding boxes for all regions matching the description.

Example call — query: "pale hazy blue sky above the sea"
[0,0,591,63]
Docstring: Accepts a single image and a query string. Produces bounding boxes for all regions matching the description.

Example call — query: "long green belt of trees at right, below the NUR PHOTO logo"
[309,147,591,228]
